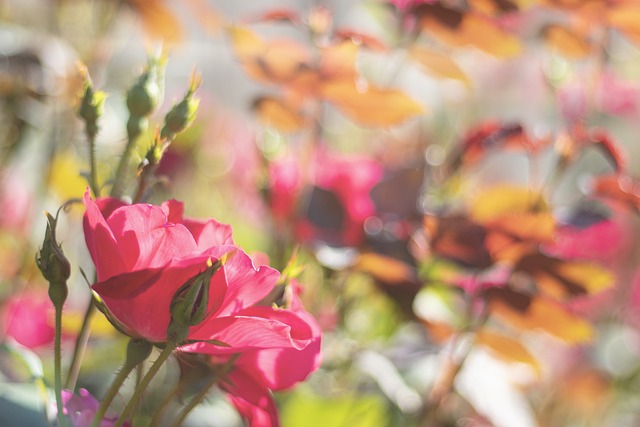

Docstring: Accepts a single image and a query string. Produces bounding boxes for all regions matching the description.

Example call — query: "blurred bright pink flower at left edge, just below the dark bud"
[2,292,55,349]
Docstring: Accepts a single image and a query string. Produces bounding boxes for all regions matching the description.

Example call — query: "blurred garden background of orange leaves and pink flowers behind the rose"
[0,0,640,427]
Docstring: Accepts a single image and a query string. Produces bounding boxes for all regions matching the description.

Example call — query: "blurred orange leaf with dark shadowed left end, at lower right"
[486,288,593,344]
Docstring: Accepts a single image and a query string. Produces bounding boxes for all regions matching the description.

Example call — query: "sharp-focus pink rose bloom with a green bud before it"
[84,192,278,351]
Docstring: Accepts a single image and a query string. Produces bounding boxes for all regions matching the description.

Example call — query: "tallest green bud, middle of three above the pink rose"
[127,59,162,117]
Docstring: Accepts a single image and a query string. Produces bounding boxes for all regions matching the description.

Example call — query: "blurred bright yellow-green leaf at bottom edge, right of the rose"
[282,392,389,427]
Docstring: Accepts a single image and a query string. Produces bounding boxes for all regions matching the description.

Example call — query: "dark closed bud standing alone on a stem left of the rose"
[36,212,71,307]
